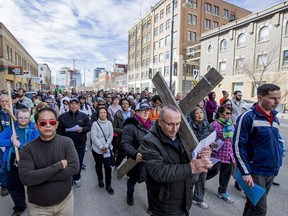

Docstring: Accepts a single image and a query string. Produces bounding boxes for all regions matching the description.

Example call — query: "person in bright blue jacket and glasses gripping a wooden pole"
[0,109,39,216]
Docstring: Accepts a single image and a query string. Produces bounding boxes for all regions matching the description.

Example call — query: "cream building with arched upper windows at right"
[200,1,288,103]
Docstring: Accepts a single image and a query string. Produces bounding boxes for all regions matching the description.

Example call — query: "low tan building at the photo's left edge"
[0,23,40,90]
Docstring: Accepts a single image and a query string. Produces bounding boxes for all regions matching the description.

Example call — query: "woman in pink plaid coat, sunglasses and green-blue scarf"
[206,105,235,203]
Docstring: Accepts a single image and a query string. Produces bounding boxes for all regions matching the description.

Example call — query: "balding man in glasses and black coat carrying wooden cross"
[142,105,212,216]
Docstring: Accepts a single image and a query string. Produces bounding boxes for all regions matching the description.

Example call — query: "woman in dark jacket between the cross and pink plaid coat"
[189,106,214,209]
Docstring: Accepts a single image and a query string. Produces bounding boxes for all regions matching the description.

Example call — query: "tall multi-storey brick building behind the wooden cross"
[127,0,251,93]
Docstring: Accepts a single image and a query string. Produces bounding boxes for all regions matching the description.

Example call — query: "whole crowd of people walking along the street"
[0,84,284,216]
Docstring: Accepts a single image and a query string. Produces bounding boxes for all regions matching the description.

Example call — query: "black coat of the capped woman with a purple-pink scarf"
[121,117,152,183]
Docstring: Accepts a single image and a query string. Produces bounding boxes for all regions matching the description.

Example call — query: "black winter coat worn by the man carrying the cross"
[142,123,197,216]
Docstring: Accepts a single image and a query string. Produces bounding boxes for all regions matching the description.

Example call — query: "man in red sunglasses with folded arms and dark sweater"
[19,107,79,216]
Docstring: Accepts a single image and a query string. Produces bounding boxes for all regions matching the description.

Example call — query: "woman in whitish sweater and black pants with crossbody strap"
[91,107,114,195]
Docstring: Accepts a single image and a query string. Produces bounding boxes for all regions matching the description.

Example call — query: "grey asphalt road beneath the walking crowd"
[0,119,288,216]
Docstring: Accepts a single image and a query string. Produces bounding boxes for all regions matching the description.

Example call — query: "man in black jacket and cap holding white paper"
[57,98,91,187]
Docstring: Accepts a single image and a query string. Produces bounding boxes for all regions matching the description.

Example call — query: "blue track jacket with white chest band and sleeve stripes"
[233,106,282,176]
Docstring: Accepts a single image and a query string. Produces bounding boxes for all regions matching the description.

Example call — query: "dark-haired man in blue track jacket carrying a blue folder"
[233,84,282,216]
